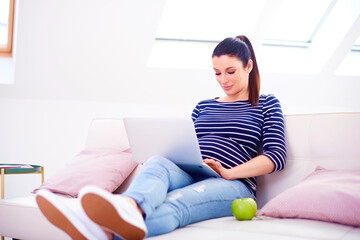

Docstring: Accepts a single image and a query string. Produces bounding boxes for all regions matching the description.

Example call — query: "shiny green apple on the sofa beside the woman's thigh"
[231,198,257,220]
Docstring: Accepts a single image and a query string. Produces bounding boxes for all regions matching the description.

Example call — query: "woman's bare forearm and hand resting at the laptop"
[204,155,275,180]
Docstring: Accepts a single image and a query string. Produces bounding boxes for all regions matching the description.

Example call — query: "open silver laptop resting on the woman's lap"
[124,117,220,177]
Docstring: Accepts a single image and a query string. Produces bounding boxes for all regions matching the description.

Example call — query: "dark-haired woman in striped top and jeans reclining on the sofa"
[37,36,286,239]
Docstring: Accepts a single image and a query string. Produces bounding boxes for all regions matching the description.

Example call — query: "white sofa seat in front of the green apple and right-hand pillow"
[151,217,360,240]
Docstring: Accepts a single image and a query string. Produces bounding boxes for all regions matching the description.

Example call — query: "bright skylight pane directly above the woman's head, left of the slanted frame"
[156,0,266,42]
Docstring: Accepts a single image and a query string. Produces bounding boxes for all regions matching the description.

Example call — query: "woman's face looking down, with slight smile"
[212,55,252,101]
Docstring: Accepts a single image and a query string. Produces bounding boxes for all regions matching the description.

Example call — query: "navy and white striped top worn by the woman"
[192,95,286,194]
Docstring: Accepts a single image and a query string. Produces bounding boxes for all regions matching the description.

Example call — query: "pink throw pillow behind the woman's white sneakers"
[34,150,138,197]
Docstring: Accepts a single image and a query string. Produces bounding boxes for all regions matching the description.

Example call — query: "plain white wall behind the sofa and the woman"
[0,0,360,197]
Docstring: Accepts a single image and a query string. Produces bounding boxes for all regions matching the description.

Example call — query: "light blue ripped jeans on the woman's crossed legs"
[115,156,254,239]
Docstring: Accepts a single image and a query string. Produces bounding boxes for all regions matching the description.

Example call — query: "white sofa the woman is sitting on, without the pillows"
[0,113,360,240]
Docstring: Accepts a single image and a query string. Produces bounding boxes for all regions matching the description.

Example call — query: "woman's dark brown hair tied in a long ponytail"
[212,35,260,106]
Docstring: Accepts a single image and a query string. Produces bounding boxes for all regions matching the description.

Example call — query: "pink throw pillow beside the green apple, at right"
[257,167,360,227]
